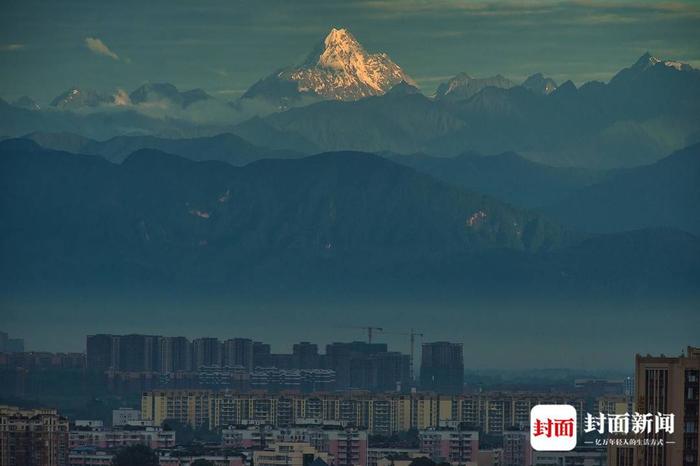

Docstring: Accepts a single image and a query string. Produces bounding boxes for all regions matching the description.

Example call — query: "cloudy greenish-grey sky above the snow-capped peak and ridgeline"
[0,0,700,101]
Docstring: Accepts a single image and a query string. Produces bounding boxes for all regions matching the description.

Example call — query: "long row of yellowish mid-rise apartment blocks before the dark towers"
[141,390,586,435]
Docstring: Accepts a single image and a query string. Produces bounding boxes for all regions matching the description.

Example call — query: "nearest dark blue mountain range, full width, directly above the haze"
[0,139,700,293]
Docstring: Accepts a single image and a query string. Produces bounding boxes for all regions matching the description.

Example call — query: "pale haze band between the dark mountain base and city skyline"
[0,290,700,370]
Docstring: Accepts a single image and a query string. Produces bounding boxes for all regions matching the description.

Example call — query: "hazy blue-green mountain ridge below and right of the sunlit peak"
[245,52,700,168]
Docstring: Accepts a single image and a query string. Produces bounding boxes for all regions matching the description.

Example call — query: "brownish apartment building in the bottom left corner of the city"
[0,406,69,466]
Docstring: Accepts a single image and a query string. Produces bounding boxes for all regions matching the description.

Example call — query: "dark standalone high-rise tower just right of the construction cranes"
[420,341,464,393]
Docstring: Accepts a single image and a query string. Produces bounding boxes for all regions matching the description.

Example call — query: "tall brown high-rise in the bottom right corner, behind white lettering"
[634,346,700,466]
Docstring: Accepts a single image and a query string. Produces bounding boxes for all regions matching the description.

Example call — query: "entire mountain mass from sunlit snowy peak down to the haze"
[0,29,700,296]
